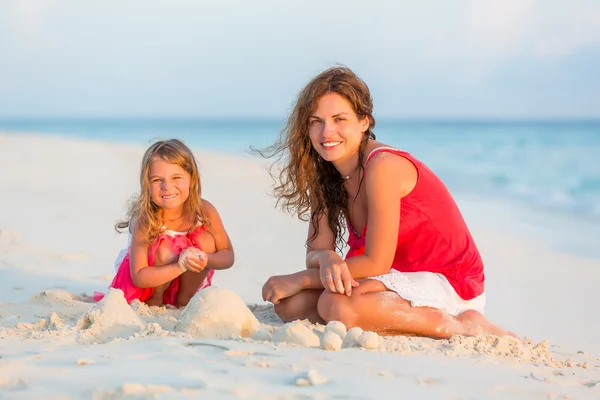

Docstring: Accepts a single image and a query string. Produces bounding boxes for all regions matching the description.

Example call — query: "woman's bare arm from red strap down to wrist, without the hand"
[346,153,417,279]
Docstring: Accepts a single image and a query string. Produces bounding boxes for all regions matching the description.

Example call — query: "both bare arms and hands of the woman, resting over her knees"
[270,153,417,301]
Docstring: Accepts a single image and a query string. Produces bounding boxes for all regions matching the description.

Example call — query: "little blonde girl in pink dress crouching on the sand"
[94,139,234,307]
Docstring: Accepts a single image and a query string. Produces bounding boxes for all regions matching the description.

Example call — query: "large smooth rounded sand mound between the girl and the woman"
[174,287,260,338]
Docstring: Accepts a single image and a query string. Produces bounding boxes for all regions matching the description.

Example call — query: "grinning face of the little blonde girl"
[148,157,191,210]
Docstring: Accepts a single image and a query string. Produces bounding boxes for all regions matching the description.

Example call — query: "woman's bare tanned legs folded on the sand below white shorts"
[318,279,516,339]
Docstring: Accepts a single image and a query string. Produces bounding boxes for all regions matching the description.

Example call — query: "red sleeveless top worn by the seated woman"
[346,147,484,300]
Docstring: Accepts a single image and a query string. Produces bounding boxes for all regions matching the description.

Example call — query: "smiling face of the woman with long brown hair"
[308,92,369,163]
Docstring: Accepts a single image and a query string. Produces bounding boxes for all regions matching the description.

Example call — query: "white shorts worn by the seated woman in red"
[369,269,485,317]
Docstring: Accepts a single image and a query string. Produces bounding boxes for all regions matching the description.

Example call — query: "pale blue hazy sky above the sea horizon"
[0,0,600,118]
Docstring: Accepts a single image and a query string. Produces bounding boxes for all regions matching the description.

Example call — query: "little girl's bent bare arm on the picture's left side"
[130,221,184,288]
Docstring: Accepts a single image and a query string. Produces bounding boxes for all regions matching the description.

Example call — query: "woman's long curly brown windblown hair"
[258,66,375,251]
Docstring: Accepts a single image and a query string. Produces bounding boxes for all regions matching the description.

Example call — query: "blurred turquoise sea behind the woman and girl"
[0,119,600,256]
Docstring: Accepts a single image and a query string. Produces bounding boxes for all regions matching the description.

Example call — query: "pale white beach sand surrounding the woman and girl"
[0,133,600,399]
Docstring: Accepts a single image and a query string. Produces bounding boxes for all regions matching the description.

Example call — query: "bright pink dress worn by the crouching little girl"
[94,225,215,306]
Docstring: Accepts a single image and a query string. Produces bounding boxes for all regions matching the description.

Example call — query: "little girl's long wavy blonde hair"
[115,139,208,243]
